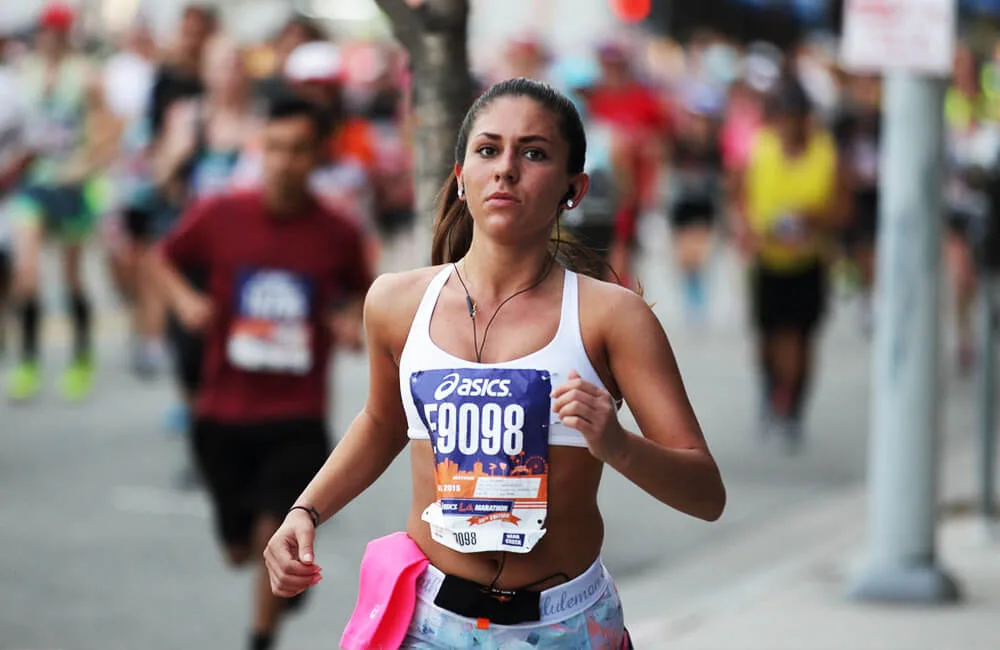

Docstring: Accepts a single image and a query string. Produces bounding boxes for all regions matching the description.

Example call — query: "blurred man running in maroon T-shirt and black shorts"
[157,99,371,650]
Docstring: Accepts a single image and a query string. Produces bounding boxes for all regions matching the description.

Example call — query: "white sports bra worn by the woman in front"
[399,264,607,447]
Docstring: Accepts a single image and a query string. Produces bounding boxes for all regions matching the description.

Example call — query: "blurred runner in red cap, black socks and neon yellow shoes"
[8,3,115,401]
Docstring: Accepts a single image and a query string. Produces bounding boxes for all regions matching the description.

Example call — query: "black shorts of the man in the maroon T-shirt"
[191,418,330,547]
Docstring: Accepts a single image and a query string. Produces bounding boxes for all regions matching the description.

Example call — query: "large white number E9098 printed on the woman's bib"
[424,402,524,456]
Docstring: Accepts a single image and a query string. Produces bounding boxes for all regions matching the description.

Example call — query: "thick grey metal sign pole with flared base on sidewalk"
[850,72,959,602]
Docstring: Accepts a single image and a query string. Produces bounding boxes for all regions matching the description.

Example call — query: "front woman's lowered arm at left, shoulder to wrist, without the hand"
[295,275,408,521]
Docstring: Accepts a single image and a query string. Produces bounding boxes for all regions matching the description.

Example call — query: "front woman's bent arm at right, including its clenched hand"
[553,285,726,521]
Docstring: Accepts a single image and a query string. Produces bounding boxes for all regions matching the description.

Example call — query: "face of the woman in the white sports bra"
[455,97,572,244]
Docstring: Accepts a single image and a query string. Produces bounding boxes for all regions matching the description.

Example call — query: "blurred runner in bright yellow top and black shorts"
[743,79,849,449]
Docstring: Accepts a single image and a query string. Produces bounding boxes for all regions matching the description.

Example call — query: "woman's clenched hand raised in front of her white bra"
[552,370,628,463]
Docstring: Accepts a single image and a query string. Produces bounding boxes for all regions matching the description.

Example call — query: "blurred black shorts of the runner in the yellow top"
[751,262,827,335]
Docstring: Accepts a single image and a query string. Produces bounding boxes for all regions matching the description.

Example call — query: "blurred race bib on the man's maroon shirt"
[226,270,313,375]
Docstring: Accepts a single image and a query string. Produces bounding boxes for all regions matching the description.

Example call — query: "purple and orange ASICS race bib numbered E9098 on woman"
[410,368,552,553]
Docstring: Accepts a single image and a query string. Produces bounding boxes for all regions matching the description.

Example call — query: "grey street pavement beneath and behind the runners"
[0,214,974,650]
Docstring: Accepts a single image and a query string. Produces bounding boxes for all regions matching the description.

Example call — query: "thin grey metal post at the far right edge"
[979,270,997,536]
